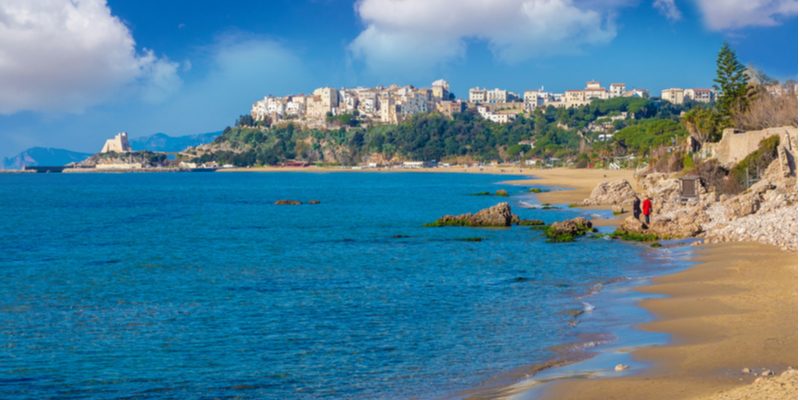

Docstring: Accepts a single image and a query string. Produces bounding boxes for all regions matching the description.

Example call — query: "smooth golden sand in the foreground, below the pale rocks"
[544,243,798,400]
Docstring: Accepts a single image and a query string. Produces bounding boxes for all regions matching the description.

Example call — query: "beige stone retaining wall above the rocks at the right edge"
[701,126,797,168]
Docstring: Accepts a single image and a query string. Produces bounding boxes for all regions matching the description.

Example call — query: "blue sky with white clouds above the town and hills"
[0,0,798,157]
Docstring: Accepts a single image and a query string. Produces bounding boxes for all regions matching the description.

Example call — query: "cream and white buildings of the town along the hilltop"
[250,79,715,129]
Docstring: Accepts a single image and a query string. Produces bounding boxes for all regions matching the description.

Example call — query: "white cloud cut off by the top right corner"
[696,0,797,31]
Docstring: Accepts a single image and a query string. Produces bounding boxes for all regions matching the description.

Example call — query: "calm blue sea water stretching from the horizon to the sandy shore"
[0,173,680,399]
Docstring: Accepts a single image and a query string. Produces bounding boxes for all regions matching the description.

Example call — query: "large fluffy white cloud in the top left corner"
[0,0,181,114]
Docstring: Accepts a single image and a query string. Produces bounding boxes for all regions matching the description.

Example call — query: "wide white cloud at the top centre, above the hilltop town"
[348,0,630,78]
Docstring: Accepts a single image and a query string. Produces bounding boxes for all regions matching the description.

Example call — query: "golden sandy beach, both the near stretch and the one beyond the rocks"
[467,169,798,400]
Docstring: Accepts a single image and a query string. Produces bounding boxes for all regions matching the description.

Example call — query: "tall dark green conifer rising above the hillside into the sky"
[714,41,750,117]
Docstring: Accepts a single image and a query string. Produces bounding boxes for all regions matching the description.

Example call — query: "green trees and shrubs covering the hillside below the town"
[195,97,690,167]
